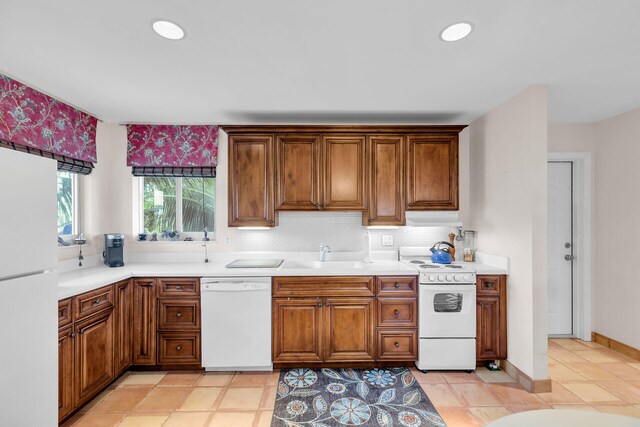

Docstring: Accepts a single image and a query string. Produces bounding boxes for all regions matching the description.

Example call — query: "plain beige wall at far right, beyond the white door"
[594,109,640,348]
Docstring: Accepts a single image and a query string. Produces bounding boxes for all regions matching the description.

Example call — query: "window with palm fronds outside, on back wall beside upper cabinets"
[140,177,216,240]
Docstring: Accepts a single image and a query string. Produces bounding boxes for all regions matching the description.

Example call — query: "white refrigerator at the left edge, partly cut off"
[0,148,58,427]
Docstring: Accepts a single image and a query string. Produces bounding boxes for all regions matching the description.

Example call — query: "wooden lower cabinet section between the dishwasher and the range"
[273,276,418,367]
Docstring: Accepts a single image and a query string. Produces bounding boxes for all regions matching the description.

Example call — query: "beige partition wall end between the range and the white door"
[469,86,547,379]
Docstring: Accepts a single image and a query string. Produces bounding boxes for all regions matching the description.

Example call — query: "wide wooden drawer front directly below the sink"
[273,276,374,297]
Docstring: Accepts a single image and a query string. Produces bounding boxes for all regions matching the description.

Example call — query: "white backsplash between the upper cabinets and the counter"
[236,212,451,252]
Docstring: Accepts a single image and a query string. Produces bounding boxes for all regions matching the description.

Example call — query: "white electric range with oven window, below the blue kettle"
[400,247,476,371]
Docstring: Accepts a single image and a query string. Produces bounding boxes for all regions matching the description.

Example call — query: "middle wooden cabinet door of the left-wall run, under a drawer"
[74,310,115,406]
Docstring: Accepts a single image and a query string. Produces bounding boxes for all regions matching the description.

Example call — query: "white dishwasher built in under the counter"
[200,277,273,371]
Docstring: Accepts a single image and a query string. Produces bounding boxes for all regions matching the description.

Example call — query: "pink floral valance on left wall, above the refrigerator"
[0,74,98,167]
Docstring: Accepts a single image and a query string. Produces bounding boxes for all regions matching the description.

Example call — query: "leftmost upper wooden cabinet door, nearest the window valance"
[229,135,276,227]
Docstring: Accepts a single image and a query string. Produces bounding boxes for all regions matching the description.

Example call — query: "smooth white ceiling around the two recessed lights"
[0,0,640,124]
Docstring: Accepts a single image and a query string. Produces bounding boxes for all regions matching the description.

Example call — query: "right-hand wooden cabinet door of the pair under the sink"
[324,298,375,362]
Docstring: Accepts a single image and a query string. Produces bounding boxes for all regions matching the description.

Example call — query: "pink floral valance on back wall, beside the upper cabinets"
[127,124,218,176]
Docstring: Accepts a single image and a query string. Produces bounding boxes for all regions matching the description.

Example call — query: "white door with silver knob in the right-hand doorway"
[547,162,573,335]
